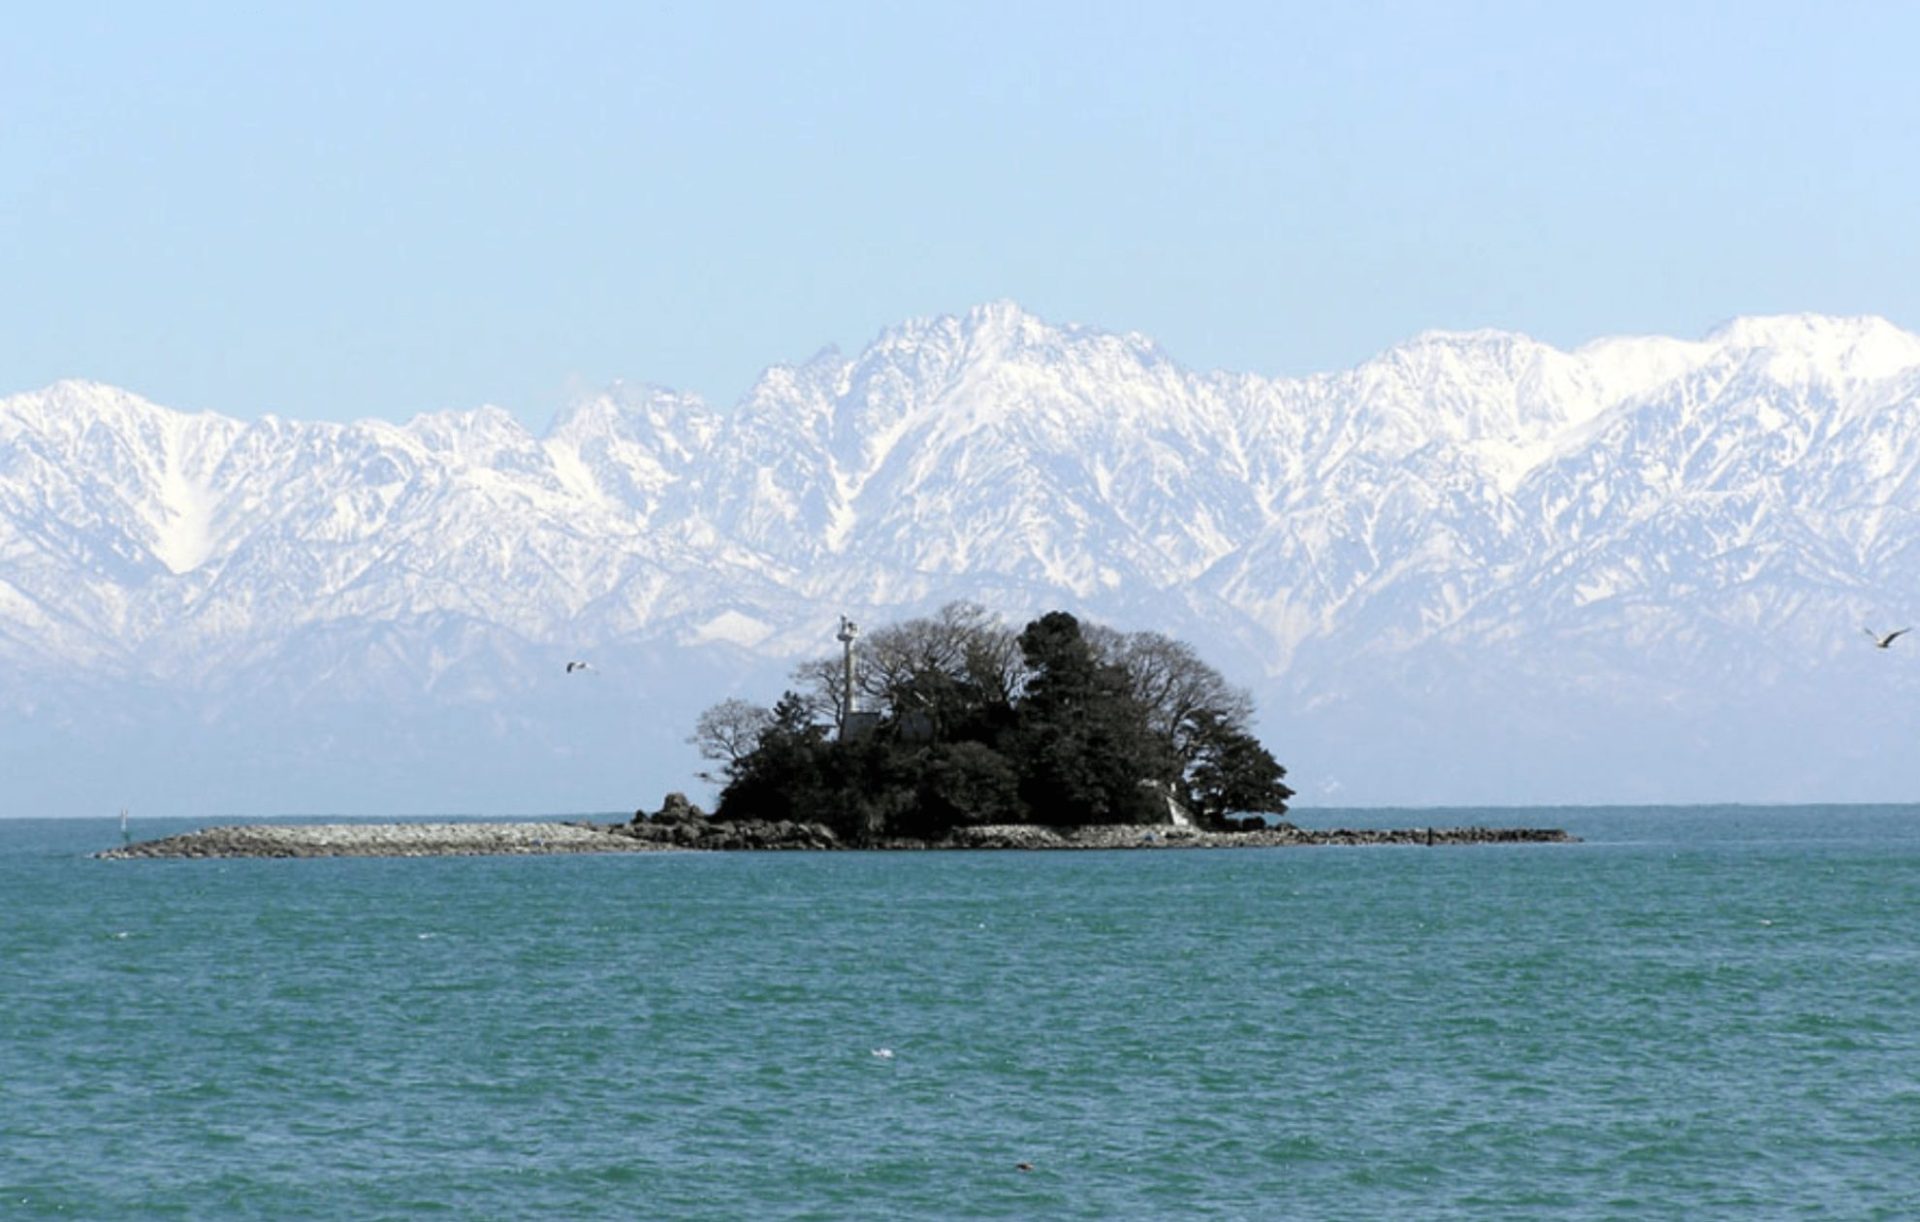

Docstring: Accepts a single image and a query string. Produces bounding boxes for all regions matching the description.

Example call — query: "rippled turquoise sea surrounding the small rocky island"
[0,807,1920,1218]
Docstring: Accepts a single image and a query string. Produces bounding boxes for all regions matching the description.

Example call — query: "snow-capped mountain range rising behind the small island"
[0,304,1920,815]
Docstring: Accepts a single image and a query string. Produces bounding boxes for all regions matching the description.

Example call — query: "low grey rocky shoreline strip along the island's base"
[94,819,1576,861]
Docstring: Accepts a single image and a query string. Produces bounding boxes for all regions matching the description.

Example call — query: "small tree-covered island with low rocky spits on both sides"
[100,603,1574,859]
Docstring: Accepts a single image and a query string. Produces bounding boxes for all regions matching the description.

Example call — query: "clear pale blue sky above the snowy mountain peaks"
[0,2,1920,427]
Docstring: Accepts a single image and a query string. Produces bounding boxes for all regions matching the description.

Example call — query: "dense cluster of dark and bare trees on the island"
[691,603,1292,843]
